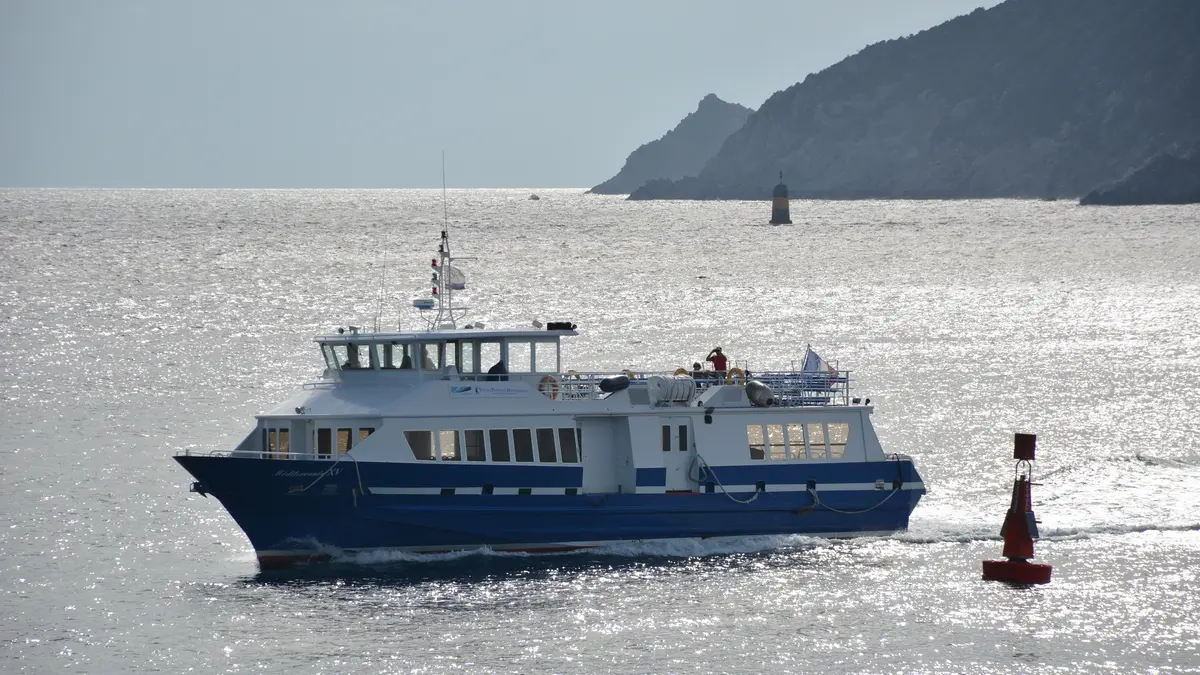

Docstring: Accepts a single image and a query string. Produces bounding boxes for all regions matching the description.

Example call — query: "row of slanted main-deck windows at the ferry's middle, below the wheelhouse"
[404,428,582,464]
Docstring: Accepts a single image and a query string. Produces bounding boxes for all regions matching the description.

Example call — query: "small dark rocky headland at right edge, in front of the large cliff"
[1079,151,1200,205]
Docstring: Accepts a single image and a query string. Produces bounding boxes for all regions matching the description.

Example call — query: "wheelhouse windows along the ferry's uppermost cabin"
[322,340,558,374]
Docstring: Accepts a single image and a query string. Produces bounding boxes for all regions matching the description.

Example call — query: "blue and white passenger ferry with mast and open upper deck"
[175,227,925,568]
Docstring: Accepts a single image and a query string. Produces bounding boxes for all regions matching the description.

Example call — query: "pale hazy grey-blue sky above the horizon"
[0,0,997,187]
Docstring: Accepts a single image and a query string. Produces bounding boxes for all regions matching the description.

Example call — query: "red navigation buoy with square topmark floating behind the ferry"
[983,434,1050,584]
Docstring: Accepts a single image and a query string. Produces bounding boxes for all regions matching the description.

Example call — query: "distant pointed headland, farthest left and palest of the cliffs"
[589,94,754,195]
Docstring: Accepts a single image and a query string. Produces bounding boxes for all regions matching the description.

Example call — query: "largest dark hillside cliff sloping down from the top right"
[630,0,1200,199]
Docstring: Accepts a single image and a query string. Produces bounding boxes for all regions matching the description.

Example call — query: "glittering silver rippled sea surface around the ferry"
[0,190,1200,674]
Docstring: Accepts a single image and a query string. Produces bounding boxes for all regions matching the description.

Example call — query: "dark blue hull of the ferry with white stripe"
[175,456,924,567]
